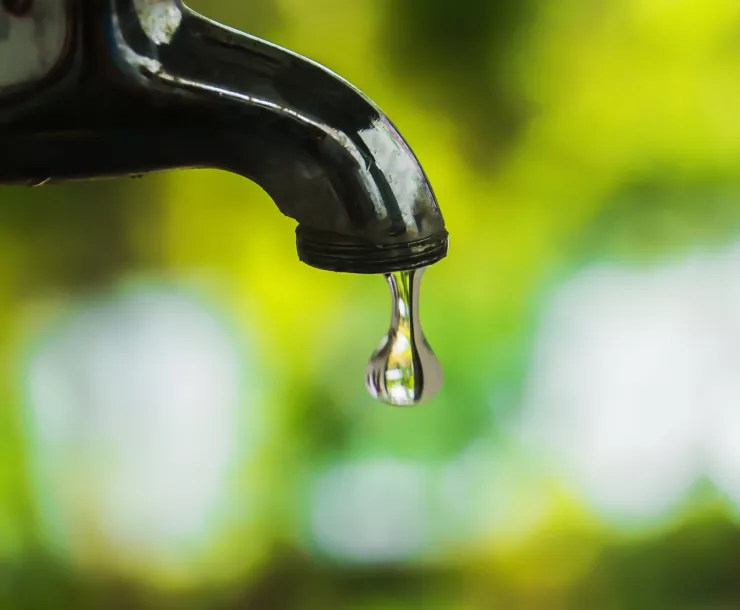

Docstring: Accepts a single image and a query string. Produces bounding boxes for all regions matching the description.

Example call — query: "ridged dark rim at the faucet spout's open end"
[296,226,449,274]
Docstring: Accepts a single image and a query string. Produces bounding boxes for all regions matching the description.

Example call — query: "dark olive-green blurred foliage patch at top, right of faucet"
[383,0,535,168]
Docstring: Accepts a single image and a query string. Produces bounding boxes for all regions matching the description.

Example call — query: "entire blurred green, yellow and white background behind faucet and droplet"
[0,0,740,610]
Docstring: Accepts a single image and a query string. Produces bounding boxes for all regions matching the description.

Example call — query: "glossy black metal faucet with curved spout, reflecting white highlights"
[0,0,447,273]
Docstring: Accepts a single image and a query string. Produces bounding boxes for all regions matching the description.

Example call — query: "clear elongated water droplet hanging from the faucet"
[366,269,442,407]
